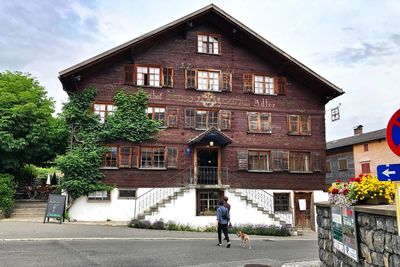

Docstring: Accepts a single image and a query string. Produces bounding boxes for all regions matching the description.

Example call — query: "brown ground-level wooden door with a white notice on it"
[294,192,311,228]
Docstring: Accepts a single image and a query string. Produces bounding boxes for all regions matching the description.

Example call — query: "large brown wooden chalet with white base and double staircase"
[59,5,343,230]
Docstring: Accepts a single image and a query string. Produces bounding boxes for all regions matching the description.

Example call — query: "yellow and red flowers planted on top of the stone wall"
[328,174,395,206]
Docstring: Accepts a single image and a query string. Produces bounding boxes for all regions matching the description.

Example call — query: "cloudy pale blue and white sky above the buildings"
[0,0,400,141]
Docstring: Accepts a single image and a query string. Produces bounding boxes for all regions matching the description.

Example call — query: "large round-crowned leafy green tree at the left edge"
[0,71,69,175]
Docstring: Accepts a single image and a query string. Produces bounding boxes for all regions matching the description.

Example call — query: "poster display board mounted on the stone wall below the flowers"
[332,207,358,262]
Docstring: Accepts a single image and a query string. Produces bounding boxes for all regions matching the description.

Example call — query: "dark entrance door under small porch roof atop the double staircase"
[197,147,218,184]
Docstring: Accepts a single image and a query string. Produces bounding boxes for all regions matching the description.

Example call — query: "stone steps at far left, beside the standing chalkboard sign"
[4,200,47,221]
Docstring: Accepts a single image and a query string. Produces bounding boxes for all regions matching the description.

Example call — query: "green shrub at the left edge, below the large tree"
[0,174,15,218]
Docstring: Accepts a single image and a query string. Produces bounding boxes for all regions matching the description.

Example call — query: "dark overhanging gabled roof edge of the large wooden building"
[59,4,344,102]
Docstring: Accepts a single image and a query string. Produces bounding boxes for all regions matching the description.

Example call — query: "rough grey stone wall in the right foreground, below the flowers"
[316,202,400,267]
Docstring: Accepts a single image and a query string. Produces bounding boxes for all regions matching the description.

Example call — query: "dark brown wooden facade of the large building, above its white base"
[60,6,342,193]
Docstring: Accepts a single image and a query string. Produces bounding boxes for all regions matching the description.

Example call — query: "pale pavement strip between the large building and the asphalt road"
[0,220,317,241]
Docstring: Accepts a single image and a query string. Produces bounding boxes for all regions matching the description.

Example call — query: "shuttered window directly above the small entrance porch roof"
[185,108,231,130]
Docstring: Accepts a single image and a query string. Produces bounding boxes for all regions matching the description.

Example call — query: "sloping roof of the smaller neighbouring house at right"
[326,128,386,150]
